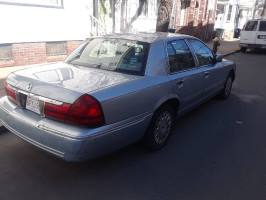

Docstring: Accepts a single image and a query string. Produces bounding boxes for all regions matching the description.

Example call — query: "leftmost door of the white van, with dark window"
[240,20,258,44]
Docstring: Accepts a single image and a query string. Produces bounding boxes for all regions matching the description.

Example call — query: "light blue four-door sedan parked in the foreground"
[0,33,236,161]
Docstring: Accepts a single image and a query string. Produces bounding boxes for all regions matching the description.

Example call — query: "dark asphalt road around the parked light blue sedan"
[0,53,266,200]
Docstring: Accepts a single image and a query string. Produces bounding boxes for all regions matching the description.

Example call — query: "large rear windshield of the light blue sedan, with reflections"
[65,38,149,75]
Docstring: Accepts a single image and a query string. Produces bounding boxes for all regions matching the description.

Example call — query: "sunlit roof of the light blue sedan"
[103,32,194,43]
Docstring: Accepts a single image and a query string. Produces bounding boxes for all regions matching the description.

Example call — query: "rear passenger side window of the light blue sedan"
[167,40,195,72]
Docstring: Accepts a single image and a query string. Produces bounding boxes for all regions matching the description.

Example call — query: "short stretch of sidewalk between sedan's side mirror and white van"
[207,39,240,56]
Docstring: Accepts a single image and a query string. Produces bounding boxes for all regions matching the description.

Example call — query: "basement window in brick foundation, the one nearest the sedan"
[46,42,67,56]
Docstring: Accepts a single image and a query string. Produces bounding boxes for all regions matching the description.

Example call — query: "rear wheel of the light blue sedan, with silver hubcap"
[143,105,175,151]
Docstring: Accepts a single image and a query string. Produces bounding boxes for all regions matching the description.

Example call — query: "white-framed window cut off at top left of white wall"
[0,0,63,8]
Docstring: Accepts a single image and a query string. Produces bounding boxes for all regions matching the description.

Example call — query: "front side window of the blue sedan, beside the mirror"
[189,39,214,66]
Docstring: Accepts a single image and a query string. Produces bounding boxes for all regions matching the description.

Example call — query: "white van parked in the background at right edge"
[240,19,266,52]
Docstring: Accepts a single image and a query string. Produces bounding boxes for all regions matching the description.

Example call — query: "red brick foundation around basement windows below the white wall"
[0,41,81,67]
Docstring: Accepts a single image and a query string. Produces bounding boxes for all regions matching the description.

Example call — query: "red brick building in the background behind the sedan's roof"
[171,0,217,41]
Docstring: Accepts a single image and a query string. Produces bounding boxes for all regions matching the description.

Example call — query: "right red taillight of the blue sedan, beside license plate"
[44,94,104,126]
